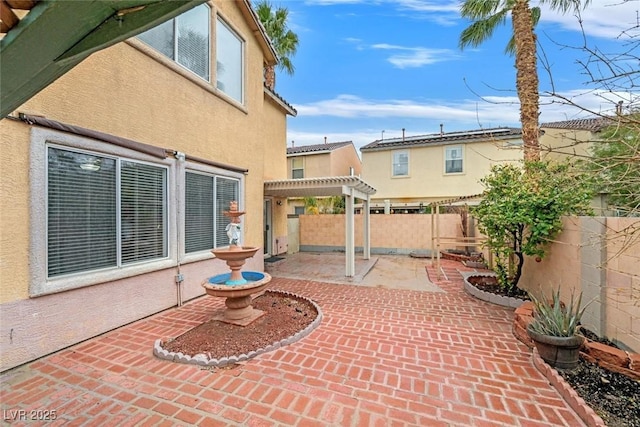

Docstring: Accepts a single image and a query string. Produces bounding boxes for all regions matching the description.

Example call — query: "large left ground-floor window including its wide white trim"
[29,128,177,296]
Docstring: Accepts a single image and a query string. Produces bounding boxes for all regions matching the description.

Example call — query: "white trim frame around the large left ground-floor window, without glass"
[29,127,178,296]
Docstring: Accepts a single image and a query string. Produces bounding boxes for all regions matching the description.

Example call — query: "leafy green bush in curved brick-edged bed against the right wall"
[471,161,593,295]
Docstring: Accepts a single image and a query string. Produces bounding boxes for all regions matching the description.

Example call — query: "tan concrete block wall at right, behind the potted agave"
[520,217,640,353]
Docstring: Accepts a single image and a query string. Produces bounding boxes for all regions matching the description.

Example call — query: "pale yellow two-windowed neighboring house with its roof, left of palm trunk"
[360,128,523,213]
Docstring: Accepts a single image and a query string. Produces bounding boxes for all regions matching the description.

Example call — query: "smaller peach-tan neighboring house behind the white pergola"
[287,140,362,215]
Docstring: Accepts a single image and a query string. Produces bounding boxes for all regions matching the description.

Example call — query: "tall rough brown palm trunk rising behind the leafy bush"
[511,0,540,161]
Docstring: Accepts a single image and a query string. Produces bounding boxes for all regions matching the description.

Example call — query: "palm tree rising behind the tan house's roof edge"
[255,0,298,89]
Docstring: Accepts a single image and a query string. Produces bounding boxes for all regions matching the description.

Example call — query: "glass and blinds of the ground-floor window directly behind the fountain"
[184,171,240,254]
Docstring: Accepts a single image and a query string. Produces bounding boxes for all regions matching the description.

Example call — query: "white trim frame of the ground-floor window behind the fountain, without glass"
[177,161,245,264]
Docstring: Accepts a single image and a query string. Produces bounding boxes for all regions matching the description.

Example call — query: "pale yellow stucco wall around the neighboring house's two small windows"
[362,142,522,204]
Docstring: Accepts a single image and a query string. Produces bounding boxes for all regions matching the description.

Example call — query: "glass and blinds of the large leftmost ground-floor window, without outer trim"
[46,146,168,278]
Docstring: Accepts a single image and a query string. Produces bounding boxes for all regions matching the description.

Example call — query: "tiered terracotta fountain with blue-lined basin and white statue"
[202,201,271,326]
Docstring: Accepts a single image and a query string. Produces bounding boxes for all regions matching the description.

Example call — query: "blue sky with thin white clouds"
[272,0,640,153]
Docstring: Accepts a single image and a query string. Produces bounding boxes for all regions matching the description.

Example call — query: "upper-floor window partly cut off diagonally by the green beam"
[138,4,211,81]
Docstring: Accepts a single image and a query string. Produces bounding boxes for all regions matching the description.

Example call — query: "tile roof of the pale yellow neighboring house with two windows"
[360,128,522,151]
